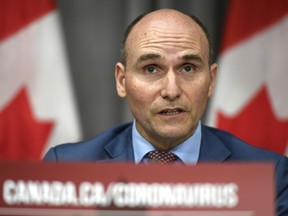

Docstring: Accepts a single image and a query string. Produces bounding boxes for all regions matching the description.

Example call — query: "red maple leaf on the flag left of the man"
[0,88,53,160]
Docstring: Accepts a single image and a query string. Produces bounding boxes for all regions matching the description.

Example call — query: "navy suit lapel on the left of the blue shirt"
[105,124,134,162]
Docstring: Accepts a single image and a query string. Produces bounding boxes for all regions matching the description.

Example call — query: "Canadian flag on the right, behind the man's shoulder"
[208,0,288,154]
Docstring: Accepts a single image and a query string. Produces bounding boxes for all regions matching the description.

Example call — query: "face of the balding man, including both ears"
[115,12,216,150]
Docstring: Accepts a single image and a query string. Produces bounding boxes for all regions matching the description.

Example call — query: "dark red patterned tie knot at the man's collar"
[147,150,177,164]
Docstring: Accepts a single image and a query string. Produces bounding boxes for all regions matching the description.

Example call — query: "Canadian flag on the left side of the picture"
[0,0,81,160]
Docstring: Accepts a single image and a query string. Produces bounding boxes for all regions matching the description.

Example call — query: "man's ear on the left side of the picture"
[115,62,126,98]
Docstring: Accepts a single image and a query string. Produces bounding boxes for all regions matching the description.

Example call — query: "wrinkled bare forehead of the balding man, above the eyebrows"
[126,11,209,55]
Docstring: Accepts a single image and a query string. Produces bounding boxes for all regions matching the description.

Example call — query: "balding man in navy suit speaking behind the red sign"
[44,9,288,215]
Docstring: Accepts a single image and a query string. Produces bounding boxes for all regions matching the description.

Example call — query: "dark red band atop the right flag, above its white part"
[221,0,288,52]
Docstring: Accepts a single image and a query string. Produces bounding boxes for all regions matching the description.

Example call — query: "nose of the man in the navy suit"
[161,70,181,101]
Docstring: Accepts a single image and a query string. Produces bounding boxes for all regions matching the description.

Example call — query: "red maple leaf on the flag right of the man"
[217,86,288,154]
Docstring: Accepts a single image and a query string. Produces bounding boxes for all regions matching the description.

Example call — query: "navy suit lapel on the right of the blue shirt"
[199,126,231,162]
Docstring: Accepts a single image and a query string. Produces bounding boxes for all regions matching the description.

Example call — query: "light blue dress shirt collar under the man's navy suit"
[132,120,201,164]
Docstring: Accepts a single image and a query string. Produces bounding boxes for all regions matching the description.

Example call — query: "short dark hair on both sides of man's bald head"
[121,12,214,65]
